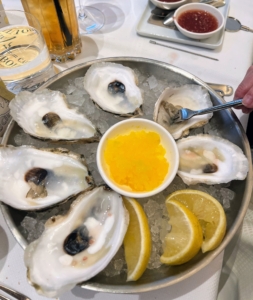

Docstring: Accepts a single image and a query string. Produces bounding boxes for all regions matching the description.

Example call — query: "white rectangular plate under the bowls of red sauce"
[136,0,230,49]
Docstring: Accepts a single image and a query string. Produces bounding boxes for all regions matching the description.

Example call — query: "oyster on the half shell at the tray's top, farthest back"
[84,62,143,115]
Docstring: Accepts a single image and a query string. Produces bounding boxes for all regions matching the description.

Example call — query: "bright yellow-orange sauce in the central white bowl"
[104,130,169,192]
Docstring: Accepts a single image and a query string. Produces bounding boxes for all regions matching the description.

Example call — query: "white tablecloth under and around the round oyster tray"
[0,0,253,300]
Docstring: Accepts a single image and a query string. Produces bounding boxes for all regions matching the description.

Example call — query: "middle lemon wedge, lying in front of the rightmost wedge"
[160,200,203,265]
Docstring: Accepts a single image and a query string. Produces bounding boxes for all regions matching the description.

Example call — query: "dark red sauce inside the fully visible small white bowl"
[177,9,218,33]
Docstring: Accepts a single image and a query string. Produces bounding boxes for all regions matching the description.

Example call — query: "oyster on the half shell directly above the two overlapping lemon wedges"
[177,134,249,185]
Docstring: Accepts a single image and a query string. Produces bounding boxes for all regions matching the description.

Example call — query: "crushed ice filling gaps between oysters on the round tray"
[14,69,235,277]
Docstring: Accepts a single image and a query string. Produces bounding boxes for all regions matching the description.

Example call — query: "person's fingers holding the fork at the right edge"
[234,66,253,114]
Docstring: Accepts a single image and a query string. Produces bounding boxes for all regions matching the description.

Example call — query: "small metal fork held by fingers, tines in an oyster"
[171,99,242,123]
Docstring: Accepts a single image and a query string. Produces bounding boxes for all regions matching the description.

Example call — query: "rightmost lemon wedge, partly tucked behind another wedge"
[166,190,227,253]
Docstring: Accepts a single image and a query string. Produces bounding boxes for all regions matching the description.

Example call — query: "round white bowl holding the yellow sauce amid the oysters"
[97,119,179,198]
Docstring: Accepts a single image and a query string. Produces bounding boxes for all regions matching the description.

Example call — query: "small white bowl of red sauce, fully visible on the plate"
[174,3,225,40]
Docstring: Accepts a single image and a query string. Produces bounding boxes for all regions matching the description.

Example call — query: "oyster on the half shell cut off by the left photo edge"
[0,146,93,210]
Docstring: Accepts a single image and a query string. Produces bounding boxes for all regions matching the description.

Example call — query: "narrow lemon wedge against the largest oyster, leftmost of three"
[123,197,151,281]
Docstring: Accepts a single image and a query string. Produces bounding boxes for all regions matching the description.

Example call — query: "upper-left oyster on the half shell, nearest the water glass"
[9,89,97,141]
